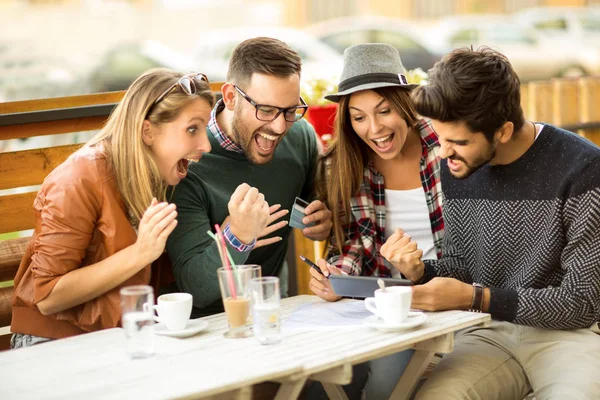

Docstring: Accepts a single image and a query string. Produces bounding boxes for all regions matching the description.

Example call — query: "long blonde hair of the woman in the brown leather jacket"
[86,68,214,226]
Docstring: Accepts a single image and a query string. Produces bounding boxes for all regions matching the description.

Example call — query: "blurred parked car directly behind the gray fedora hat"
[306,16,442,71]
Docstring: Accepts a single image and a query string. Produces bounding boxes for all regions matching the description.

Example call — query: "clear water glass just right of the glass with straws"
[250,276,281,344]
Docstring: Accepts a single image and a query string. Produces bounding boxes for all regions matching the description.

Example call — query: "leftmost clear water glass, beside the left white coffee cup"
[120,285,154,358]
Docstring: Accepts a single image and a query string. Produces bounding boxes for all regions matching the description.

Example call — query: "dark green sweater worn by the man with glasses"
[167,119,317,315]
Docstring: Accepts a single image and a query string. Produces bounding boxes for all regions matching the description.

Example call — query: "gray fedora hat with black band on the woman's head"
[325,43,419,103]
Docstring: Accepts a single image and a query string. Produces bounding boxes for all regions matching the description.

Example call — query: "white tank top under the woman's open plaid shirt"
[385,187,437,278]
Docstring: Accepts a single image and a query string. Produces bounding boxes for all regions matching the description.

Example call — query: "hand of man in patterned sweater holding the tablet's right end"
[410,277,474,311]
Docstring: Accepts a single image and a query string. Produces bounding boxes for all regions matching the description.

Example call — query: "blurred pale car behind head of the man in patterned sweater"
[427,15,600,82]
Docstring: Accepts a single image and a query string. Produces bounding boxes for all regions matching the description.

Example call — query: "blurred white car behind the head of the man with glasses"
[191,27,343,81]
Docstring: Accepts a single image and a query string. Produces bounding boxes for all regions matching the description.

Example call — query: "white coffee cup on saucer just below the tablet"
[365,286,412,325]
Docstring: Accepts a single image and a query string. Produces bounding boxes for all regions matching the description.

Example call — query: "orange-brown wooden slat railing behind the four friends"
[0,78,600,349]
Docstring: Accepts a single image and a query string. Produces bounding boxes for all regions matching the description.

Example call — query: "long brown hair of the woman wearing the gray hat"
[316,87,417,251]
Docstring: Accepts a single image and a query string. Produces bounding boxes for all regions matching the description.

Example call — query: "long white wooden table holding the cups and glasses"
[0,296,490,400]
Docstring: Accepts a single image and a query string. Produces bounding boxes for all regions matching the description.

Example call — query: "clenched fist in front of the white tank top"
[379,229,425,282]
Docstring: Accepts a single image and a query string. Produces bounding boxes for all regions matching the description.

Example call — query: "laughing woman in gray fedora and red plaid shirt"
[309,43,444,399]
